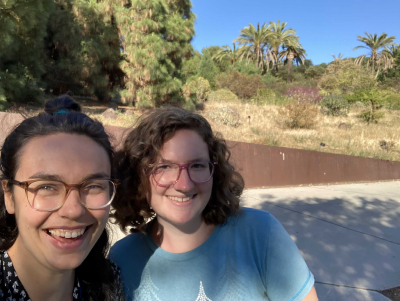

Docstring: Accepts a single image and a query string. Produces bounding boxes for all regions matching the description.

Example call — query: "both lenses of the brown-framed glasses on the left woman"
[27,179,115,210]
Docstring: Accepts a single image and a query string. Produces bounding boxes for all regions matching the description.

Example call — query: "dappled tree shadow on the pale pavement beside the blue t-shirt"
[243,193,400,290]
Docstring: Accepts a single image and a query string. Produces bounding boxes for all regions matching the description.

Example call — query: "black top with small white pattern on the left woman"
[0,251,82,301]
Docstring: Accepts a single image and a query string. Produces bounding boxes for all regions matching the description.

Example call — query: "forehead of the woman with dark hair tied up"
[16,134,111,183]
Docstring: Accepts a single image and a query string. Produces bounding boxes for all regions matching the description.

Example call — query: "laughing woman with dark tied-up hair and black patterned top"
[0,96,123,301]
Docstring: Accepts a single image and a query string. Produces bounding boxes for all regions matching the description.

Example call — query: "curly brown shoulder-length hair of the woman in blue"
[112,107,244,233]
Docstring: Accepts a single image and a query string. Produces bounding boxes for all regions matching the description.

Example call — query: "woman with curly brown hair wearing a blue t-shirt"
[110,108,318,301]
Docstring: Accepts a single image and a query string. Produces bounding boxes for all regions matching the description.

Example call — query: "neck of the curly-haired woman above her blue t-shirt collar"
[151,217,215,253]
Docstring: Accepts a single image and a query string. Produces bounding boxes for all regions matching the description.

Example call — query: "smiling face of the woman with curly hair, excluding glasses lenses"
[149,130,213,227]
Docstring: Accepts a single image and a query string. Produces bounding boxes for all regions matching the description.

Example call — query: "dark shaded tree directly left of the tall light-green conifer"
[45,0,124,99]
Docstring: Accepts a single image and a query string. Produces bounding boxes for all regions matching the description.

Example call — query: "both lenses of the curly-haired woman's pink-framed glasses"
[153,162,214,185]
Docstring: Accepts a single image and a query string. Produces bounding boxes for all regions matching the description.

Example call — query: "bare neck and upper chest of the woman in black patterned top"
[7,237,75,301]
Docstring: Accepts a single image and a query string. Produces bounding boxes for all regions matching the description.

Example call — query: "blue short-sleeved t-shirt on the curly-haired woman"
[110,208,314,301]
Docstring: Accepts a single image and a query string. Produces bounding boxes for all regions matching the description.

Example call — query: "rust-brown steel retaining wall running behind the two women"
[0,112,400,188]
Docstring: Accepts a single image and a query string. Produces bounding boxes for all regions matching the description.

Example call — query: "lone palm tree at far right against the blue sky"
[353,32,398,73]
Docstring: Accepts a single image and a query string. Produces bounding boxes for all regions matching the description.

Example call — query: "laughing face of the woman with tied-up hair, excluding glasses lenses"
[5,134,111,270]
